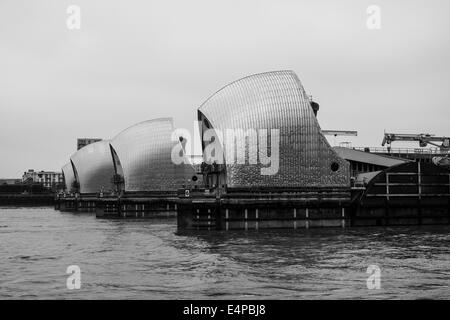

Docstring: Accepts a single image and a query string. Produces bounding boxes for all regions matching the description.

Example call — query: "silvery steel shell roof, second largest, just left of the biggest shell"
[111,118,195,192]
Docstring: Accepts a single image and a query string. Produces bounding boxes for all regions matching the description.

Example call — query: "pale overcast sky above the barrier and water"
[0,0,450,178]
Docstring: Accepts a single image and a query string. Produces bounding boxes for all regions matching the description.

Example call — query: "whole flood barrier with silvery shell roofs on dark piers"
[55,71,450,230]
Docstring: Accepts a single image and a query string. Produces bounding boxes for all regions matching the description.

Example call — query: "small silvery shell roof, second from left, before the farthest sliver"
[70,140,115,193]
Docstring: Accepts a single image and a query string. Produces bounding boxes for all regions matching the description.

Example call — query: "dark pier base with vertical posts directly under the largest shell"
[178,189,350,230]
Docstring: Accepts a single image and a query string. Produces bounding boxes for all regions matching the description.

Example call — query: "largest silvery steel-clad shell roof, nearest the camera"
[199,71,350,187]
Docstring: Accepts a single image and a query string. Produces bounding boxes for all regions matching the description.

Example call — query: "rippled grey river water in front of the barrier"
[0,208,450,299]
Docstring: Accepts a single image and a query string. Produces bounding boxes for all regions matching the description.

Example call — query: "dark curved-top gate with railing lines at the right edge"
[353,162,450,226]
